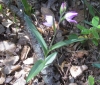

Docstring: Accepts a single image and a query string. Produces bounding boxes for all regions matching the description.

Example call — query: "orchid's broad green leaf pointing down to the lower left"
[26,60,45,82]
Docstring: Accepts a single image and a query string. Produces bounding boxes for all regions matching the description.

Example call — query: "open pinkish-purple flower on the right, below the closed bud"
[64,11,78,24]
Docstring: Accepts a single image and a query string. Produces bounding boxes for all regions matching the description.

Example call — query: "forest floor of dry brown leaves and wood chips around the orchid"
[0,0,100,85]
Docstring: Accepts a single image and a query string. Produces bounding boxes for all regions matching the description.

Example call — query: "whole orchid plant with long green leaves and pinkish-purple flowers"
[25,2,84,82]
